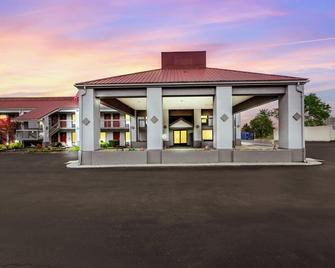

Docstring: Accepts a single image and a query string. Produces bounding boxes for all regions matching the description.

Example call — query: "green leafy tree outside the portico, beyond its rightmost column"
[304,93,331,126]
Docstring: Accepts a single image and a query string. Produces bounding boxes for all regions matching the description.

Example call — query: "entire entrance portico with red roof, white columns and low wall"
[76,49,307,165]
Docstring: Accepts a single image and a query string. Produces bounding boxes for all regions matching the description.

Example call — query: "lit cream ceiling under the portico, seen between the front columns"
[118,96,252,110]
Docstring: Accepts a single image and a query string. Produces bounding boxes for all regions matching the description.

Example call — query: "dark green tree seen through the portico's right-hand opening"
[250,109,274,138]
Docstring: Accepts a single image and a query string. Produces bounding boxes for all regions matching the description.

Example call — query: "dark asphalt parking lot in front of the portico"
[0,143,335,268]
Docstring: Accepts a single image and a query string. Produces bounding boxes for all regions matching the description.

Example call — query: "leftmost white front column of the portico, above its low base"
[80,89,100,152]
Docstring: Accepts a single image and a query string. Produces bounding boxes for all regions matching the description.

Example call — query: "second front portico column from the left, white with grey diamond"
[147,87,163,163]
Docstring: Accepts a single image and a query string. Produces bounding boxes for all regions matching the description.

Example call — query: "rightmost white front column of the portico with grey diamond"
[279,85,305,160]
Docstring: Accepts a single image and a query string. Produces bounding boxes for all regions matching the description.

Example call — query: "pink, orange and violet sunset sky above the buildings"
[0,0,335,114]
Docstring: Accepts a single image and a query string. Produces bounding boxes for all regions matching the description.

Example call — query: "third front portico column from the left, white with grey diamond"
[213,86,233,162]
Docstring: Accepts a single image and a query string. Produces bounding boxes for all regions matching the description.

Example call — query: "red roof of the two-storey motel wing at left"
[0,97,78,121]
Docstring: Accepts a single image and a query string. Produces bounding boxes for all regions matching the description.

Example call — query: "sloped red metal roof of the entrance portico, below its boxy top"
[75,68,308,86]
